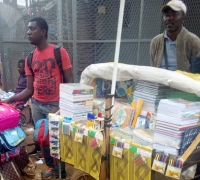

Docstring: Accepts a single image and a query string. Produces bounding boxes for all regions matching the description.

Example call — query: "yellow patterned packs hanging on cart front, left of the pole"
[69,124,105,180]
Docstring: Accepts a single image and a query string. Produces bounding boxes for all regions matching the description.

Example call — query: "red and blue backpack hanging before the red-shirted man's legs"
[33,119,49,148]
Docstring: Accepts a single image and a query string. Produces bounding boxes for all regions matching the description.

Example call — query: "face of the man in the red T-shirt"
[27,21,46,45]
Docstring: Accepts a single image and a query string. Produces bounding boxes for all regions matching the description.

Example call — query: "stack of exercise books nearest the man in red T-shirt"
[59,83,94,121]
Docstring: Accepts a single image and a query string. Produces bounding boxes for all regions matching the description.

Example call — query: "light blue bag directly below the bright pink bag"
[0,126,26,153]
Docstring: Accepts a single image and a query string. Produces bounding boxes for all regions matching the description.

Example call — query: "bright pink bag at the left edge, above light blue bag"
[0,104,20,132]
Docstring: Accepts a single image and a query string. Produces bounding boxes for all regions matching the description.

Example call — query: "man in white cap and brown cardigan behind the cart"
[150,0,200,72]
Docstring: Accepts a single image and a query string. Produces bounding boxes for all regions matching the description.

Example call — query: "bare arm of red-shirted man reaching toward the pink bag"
[2,76,34,103]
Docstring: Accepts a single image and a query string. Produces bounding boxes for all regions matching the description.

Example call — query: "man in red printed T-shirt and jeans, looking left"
[4,17,74,179]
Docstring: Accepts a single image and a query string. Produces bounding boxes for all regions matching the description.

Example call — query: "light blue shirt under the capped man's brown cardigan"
[160,31,177,71]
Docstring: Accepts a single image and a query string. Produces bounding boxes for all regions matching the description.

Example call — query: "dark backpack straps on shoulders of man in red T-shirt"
[27,45,62,75]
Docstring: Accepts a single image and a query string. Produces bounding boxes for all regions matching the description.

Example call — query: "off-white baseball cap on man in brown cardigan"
[161,0,187,14]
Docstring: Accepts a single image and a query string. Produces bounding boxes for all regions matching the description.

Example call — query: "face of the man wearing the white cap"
[163,8,184,33]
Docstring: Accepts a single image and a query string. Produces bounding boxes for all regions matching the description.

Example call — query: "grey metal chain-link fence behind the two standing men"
[0,0,200,89]
